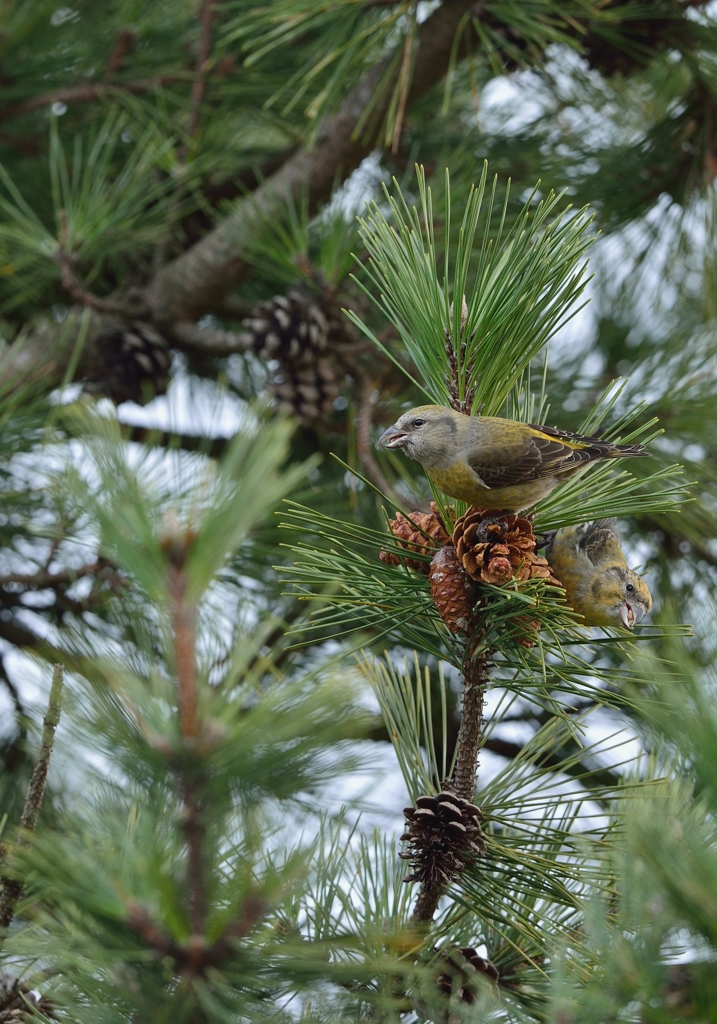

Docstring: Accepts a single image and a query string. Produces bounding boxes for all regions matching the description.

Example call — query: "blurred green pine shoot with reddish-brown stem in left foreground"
[2,415,419,1022]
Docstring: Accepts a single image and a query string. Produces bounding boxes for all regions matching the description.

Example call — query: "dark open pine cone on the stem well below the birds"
[398,793,486,886]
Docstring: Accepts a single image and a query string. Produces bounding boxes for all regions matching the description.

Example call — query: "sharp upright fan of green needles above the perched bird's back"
[349,165,590,415]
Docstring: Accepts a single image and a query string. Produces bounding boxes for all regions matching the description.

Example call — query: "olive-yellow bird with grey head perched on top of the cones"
[378,406,648,512]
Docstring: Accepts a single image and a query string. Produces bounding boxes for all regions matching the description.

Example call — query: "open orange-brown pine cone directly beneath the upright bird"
[453,506,560,587]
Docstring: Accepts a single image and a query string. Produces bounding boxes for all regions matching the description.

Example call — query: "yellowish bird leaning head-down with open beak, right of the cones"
[545,519,652,630]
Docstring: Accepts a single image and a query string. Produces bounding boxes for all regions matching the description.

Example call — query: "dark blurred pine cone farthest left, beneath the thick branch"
[85,321,170,406]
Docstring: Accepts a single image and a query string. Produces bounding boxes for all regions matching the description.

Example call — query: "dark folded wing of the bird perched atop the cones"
[468,424,614,487]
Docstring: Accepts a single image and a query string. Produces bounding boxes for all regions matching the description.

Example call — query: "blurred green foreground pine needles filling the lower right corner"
[550,642,717,1024]
